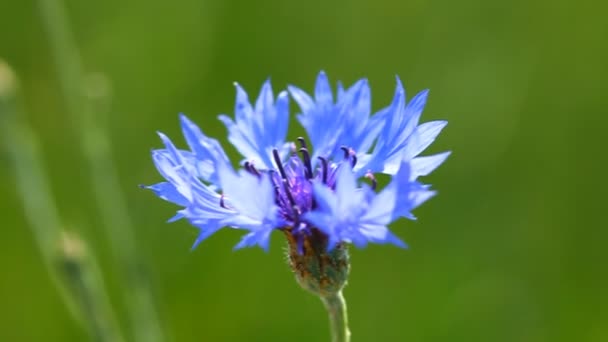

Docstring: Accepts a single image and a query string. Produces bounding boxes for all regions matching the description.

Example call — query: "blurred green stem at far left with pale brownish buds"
[0,60,124,342]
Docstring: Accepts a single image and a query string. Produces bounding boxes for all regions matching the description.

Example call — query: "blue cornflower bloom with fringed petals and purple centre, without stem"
[141,72,449,255]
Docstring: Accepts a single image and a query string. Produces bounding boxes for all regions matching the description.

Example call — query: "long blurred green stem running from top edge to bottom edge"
[38,0,164,342]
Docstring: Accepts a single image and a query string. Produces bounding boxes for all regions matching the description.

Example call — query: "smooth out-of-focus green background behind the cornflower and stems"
[0,0,608,342]
